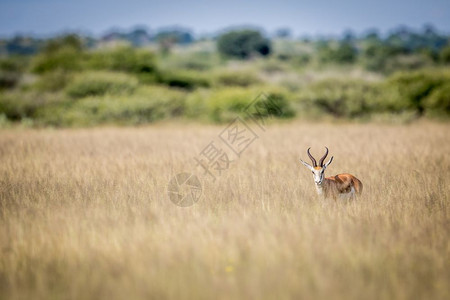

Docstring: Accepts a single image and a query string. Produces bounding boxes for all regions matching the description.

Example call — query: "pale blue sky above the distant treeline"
[0,0,450,36]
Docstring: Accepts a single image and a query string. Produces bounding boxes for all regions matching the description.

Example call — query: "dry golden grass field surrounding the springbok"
[0,122,450,299]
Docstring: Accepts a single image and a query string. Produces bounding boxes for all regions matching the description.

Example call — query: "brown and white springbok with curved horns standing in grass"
[300,147,363,201]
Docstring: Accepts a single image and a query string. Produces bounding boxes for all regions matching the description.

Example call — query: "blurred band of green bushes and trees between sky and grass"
[0,27,450,126]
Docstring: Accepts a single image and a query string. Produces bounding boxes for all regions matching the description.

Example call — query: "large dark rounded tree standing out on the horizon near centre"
[217,30,271,59]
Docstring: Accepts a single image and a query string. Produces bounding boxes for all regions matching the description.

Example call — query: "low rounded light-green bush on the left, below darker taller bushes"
[66,72,138,98]
